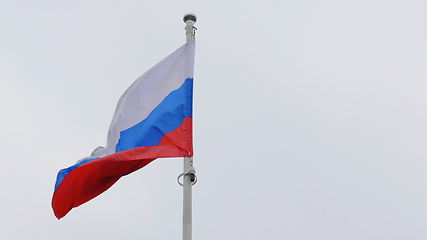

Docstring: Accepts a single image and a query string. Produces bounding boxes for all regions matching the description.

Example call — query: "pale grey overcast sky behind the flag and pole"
[0,0,427,240]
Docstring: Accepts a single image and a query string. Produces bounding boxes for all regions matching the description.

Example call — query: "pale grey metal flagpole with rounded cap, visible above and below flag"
[182,13,197,240]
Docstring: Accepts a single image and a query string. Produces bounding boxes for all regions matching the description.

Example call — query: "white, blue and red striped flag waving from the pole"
[52,41,195,219]
